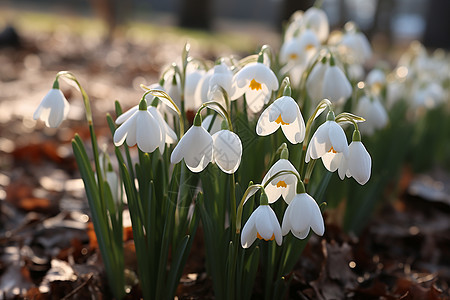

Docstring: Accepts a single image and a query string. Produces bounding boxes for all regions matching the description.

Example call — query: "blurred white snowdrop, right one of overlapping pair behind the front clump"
[320,65,352,103]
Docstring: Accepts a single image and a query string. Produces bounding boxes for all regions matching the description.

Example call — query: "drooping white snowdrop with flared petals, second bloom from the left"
[114,99,166,153]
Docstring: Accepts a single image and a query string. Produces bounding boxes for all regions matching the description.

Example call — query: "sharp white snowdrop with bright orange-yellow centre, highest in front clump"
[231,62,278,113]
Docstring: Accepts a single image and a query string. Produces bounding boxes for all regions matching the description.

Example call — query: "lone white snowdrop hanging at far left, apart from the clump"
[33,88,69,128]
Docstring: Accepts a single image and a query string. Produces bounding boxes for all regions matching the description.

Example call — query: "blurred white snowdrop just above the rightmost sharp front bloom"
[356,96,389,135]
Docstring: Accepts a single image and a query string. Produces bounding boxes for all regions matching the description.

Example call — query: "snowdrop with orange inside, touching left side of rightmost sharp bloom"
[305,111,348,172]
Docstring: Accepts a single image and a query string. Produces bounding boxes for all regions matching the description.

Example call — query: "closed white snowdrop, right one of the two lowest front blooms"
[281,193,325,239]
